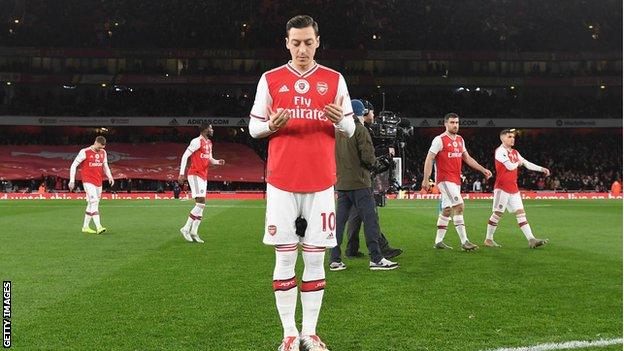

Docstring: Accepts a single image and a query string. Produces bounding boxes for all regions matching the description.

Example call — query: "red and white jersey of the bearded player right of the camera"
[429,132,466,186]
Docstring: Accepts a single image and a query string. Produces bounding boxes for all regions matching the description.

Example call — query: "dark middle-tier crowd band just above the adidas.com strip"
[0,86,622,119]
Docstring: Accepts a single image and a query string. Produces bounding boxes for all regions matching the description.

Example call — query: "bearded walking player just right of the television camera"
[422,113,492,251]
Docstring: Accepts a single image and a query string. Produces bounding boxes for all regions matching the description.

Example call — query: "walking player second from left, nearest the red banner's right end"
[178,123,225,244]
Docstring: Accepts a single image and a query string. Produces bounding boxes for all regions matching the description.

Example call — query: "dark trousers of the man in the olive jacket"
[331,188,383,262]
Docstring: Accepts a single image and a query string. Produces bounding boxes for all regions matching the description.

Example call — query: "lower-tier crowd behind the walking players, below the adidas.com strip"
[0,127,622,192]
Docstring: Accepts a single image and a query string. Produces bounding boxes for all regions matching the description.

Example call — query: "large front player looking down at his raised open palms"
[249,16,355,351]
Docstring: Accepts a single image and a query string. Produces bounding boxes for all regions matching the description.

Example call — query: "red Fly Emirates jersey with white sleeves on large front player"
[251,63,353,193]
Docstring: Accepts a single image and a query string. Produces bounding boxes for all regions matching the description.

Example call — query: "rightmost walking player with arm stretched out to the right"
[483,129,550,249]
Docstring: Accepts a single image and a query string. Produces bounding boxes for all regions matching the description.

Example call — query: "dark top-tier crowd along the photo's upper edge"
[0,0,622,51]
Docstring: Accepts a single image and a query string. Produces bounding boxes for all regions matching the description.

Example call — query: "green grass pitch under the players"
[0,200,622,351]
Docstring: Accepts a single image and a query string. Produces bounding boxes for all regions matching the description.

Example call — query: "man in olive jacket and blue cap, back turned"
[329,100,399,271]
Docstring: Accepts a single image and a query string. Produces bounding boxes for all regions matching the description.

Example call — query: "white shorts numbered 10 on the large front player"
[262,183,336,247]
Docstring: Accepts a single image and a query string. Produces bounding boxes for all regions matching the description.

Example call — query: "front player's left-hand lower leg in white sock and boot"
[273,244,299,351]
